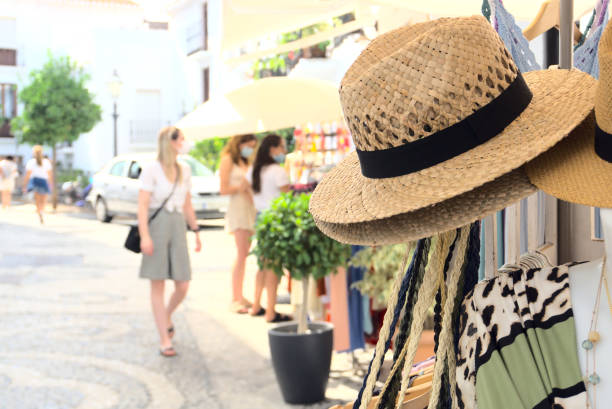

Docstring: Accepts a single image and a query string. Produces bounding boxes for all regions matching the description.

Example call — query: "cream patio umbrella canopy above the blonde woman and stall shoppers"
[176,77,342,140]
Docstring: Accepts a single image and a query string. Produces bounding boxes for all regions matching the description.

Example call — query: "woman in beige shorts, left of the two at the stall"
[219,134,257,314]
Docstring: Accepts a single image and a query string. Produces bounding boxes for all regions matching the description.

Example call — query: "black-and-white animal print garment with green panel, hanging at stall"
[456,265,586,409]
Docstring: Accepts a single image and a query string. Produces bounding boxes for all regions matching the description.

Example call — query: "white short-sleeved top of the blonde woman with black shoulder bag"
[139,160,191,213]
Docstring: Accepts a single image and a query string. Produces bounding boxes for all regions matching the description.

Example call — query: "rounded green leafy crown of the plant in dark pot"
[253,193,350,279]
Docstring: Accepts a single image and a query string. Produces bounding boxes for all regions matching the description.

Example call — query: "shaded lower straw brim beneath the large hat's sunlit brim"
[315,168,537,246]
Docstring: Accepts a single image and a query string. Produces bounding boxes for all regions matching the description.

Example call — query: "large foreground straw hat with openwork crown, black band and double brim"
[310,17,595,244]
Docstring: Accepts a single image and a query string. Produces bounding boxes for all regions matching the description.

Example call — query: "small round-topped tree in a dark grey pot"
[253,193,350,404]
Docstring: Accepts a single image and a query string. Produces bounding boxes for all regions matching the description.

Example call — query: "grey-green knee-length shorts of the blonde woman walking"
[140,209,191,281]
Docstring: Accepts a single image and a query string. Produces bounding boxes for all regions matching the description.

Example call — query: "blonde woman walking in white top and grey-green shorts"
[138,127,202,357]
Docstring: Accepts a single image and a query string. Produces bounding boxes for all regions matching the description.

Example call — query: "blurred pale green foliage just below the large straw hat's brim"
[350,244,414,305]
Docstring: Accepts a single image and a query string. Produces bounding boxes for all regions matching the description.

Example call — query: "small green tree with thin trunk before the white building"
[12,54,102,208]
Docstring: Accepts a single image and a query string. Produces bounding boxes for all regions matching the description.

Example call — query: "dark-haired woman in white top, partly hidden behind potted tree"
[247,134,291,322]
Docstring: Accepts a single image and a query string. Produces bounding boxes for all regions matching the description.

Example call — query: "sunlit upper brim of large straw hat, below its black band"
[310,70,596,224]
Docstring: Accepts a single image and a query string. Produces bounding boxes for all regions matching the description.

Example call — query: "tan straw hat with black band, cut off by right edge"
[526,25,612,207]
